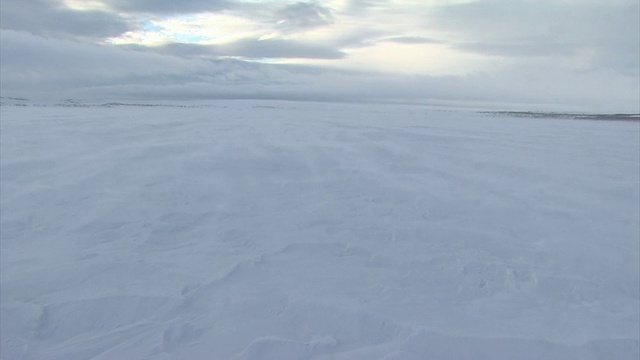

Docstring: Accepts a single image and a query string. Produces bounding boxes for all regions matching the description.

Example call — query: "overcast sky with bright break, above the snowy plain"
[0,0,640,113]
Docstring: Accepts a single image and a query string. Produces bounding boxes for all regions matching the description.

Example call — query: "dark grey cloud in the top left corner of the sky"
[0,0,135,38]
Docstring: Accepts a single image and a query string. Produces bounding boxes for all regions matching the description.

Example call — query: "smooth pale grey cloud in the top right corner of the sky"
[425,0,640,76]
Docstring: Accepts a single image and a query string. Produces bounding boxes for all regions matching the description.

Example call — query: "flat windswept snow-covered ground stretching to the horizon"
[0,101,640,360]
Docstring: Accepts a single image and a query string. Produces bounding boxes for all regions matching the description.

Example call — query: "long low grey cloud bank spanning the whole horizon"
[0,30,640,111]
